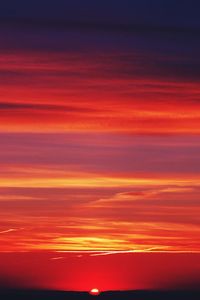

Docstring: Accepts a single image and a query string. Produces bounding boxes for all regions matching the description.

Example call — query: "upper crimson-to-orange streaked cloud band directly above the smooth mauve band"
[0,49,200,135]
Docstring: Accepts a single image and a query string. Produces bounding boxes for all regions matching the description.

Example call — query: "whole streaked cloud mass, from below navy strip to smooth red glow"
[0,13,200,253]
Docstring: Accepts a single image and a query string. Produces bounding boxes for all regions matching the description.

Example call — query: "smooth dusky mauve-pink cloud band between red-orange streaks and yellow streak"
[0,133,200,177]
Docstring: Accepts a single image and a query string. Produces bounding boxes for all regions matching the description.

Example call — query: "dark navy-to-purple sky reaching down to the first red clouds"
[0,0,200,84]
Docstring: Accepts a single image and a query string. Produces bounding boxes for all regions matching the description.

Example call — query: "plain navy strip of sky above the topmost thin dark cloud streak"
[0,0,200,27]
